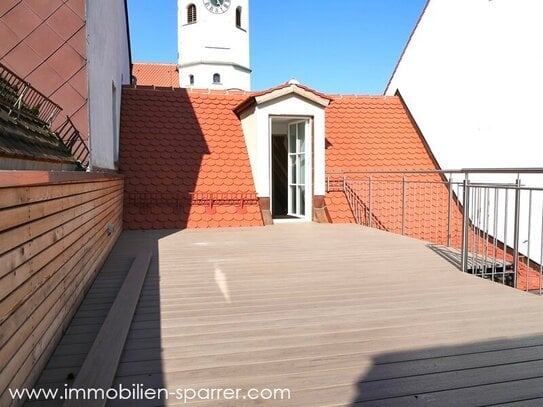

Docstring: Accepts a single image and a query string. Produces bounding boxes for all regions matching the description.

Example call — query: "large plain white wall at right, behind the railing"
[385,0,543,261]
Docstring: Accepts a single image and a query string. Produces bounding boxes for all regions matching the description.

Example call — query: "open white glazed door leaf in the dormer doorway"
[288,121,306,217]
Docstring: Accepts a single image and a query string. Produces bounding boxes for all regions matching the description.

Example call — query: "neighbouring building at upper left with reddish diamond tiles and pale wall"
[0,0,131,170]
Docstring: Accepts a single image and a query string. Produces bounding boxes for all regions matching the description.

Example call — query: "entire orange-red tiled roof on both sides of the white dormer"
[120,85,539,288]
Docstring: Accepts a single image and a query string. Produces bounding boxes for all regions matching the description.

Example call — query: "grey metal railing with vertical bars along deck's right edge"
[327,168,543,295]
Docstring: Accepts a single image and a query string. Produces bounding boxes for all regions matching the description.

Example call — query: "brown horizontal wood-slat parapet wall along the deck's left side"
[0,177,124,406]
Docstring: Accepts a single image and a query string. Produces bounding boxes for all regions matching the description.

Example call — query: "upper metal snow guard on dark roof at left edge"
[0,64,62,127]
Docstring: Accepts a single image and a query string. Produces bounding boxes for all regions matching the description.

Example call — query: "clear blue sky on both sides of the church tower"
[128,0,426,94]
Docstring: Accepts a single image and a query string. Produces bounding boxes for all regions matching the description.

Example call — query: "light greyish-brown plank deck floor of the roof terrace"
[36,224,543,406]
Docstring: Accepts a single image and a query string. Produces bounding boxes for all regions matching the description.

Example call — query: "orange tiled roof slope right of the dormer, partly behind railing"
[326,96,461,247]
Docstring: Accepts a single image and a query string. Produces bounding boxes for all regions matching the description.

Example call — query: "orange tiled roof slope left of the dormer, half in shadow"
[120,88,262,229]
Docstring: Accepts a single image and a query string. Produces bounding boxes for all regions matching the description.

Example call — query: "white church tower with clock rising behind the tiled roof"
[178,0,251,90]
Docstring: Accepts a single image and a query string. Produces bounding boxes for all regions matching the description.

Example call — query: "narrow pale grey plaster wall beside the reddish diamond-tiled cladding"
[86,0,130,169]
